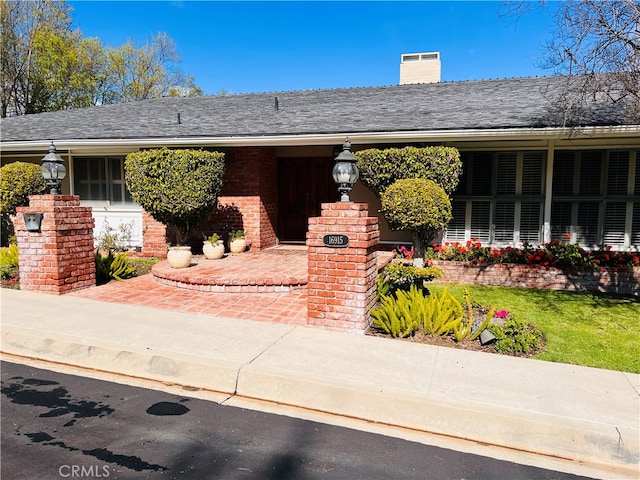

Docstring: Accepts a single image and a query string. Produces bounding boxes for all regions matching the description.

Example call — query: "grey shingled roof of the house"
[0,77,632,142]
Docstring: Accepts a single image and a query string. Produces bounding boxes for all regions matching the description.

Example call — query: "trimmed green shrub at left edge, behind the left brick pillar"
[0,162,48,246]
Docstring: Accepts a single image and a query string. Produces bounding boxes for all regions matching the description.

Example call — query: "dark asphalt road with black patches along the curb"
[1,362,596,480]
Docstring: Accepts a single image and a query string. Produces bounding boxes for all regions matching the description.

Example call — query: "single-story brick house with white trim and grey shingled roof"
[0,73,640,254]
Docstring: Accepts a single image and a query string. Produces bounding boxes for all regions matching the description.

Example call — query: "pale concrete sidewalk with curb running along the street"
[0,289,640,479]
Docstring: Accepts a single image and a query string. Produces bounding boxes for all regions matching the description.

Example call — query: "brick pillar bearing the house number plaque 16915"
[307,202,380,333]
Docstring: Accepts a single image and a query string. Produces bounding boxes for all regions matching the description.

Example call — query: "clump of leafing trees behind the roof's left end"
[0,0,202,117]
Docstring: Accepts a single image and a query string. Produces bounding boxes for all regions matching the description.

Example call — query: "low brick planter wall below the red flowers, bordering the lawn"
[433,261,640,295]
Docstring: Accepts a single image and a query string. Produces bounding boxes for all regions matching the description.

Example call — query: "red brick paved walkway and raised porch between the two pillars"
[69,249,307,325]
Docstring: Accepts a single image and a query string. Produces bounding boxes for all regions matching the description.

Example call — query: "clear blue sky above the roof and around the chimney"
[68,1,553,94]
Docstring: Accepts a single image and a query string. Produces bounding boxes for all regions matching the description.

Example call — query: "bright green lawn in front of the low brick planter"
[429,283,640,373]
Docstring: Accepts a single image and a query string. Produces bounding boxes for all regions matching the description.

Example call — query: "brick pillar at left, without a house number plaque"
[14,195,96,295]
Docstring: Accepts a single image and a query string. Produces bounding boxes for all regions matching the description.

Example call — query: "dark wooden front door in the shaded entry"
[277,158,338,242]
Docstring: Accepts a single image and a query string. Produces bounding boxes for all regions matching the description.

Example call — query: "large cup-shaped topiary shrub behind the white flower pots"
[125,148,224,244]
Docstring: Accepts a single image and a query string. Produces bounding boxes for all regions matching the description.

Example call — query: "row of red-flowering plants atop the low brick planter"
[425,238,640,268]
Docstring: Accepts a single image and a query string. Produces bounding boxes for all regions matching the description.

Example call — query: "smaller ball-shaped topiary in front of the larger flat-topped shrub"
[380,178,452,258]
